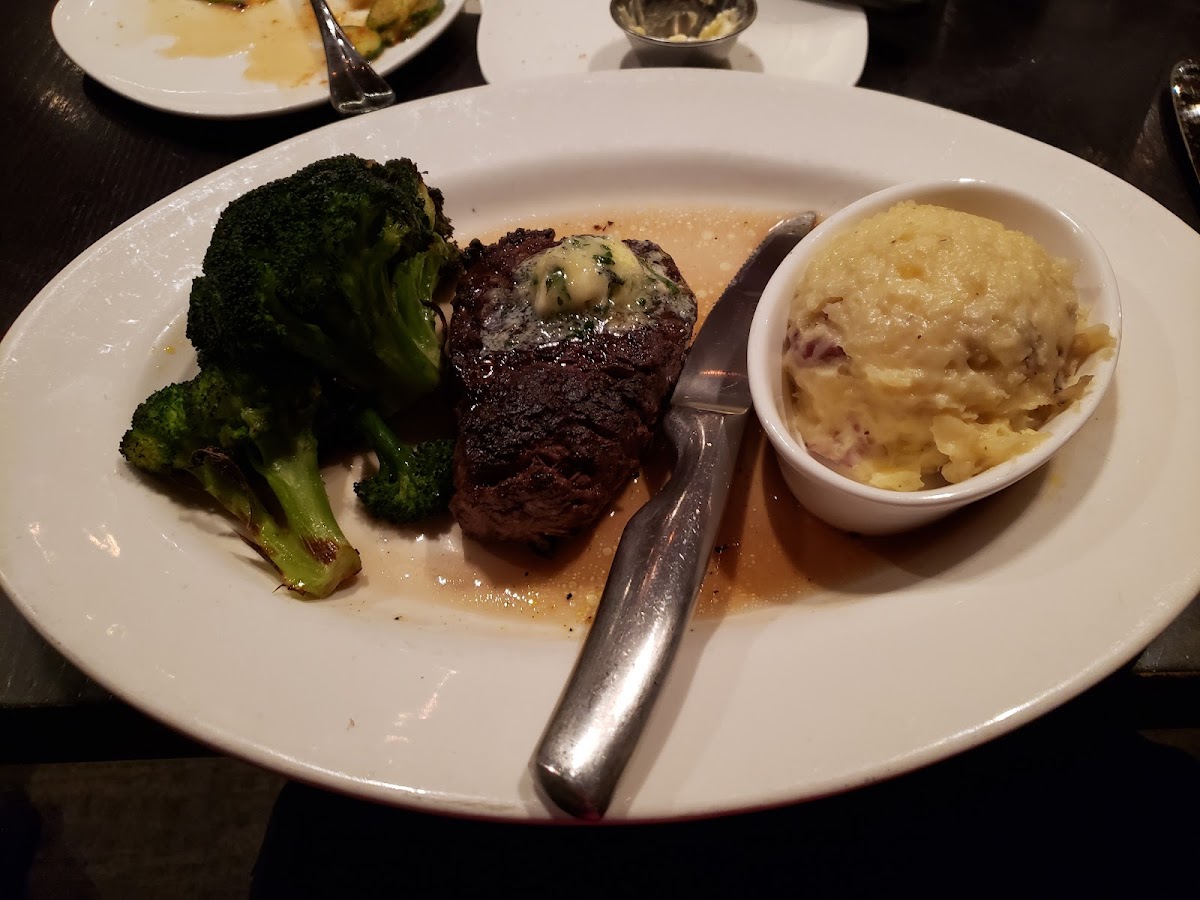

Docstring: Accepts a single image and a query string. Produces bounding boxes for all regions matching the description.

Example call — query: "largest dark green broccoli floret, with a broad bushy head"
[187,155,460,412]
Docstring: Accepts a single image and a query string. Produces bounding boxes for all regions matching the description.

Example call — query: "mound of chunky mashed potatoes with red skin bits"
[784,202,1111,491]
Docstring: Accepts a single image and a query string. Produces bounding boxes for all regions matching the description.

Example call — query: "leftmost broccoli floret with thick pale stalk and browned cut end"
[121,365,361,598]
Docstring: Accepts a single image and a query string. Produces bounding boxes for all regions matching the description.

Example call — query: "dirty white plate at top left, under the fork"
[50,0,466,119]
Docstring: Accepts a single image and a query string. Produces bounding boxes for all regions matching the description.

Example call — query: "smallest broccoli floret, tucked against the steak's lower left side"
[354,409,454,524]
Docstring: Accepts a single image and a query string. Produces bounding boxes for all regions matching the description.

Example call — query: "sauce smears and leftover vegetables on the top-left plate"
[145,0,445,88]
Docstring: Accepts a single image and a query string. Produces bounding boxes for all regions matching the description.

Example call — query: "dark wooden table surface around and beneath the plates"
[0,0,1200,883]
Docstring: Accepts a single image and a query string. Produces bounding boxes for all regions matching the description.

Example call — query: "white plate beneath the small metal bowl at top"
[478,0,866,84]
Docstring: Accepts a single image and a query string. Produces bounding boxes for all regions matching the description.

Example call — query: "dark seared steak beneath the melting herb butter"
[448,229,696,545]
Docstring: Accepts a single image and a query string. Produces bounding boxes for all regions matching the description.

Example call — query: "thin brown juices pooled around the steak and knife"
[348,209,883,628]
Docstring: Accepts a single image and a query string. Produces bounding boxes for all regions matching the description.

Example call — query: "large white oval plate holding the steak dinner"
[0,71,1200,818]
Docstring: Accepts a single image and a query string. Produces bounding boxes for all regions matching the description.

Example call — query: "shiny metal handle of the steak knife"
[534,406,748,820]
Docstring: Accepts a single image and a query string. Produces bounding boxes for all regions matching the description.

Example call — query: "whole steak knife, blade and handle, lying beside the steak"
[533,212,816,820]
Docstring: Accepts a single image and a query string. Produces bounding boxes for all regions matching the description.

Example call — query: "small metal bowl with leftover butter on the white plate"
[608,0,758,66]
